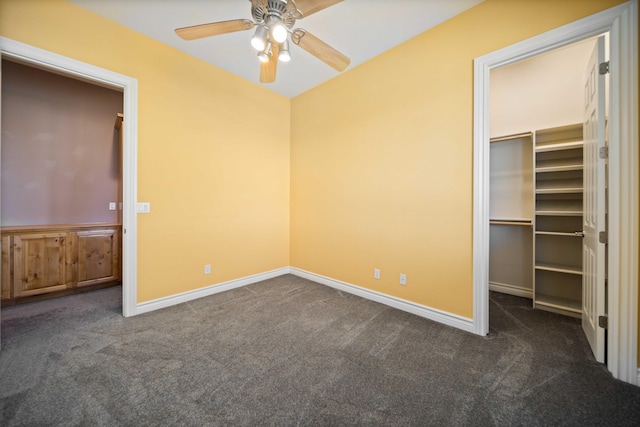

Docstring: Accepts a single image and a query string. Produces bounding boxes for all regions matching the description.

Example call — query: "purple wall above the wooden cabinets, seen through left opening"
[0,60,122,226]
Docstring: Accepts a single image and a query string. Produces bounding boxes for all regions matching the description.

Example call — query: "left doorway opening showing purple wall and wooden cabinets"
[2,58,122,306]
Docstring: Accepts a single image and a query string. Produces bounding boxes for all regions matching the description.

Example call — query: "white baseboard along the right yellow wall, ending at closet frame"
[290,267,474,333]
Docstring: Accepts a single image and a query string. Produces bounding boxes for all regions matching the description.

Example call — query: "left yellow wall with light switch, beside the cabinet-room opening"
[0,0,290,302]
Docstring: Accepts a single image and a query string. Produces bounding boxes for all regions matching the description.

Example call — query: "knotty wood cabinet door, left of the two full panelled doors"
[13,233,71,298]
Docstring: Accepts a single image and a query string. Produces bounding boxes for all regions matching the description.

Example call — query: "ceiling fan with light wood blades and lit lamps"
[176,0,351,83]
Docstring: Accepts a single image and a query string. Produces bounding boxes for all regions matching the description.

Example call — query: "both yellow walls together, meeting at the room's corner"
[0,0,622,362]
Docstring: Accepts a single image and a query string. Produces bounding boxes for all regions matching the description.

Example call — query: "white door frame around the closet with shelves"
[473,0,640,385]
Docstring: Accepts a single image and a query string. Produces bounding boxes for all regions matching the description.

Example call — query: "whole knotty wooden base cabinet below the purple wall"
[1,224,122,303]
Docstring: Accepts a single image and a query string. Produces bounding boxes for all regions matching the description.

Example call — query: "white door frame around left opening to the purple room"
[0,37,138,320]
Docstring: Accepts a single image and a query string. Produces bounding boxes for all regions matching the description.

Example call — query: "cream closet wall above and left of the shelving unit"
[489,40,595,298]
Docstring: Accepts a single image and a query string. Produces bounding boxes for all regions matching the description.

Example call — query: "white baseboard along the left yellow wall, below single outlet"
[136,267,290,314]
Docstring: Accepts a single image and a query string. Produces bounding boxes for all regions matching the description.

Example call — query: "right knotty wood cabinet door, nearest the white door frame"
[76,228,120,286]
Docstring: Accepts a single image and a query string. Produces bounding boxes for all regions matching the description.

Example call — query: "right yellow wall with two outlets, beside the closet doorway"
[291,0,621,318]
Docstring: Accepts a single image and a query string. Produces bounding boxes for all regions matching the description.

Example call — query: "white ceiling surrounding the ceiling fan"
[70,0,483,98]
